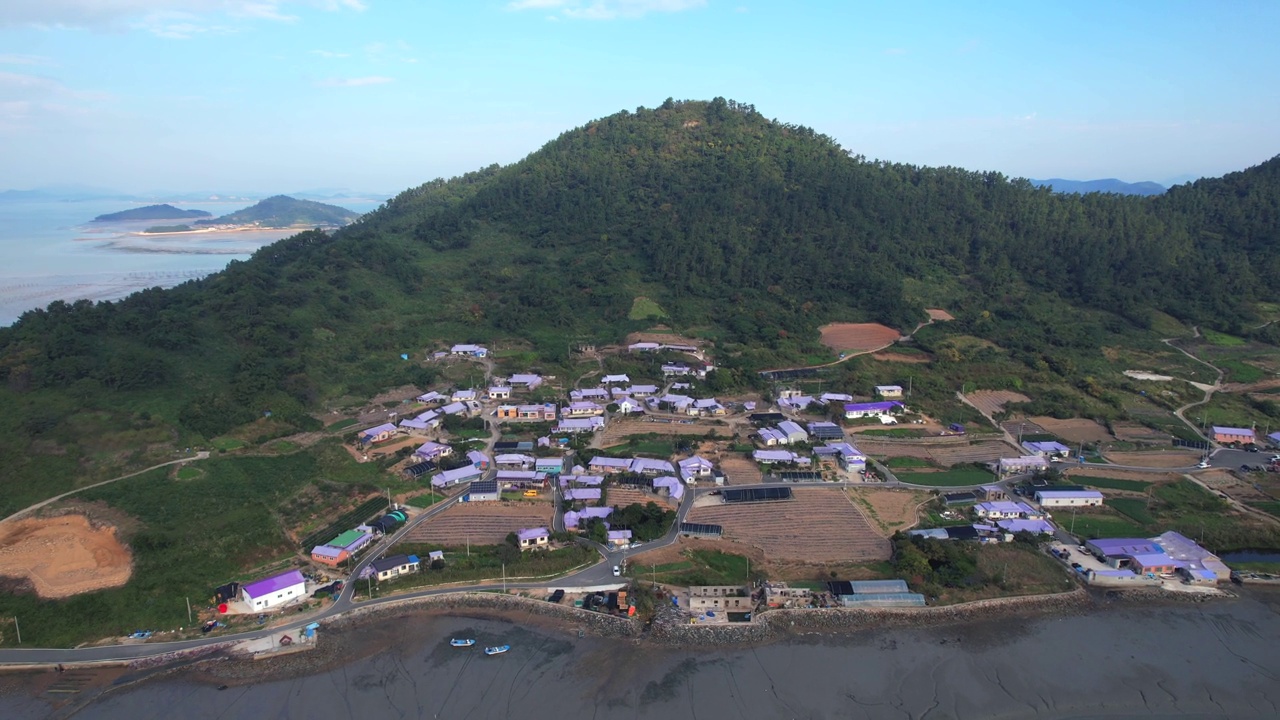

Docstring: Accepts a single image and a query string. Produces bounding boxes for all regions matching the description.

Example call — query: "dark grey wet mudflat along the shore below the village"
[0,592,1280,720]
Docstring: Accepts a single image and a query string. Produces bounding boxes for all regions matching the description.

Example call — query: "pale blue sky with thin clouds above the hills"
[0,0,1280,192]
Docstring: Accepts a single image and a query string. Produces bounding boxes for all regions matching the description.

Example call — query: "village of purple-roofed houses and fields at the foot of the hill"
[209,326,1280,638]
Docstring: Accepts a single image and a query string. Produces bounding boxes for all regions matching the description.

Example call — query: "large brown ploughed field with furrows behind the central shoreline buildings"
[686,487,891,564]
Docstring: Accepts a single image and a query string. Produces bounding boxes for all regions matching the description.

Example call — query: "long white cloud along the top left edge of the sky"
[0,0,366,37]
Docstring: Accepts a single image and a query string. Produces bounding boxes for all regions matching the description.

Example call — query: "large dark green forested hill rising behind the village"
[0,99,1280,489]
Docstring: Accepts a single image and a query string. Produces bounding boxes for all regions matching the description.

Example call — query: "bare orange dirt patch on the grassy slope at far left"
[0,515,133,598]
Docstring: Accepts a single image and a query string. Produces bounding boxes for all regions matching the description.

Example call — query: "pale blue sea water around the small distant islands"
[0,200,380,325]
